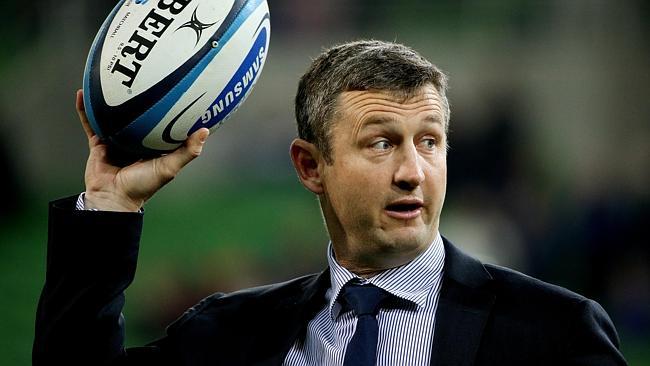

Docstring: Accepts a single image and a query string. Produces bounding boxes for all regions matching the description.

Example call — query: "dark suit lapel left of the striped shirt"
[246,268,330,366]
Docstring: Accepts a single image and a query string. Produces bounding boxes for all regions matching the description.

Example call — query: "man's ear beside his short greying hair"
[289,139,325,194]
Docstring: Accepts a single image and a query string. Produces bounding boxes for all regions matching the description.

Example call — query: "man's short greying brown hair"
[295,40,449,162]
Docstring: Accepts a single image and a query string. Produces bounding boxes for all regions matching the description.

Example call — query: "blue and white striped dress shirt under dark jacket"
[284,234,445,366]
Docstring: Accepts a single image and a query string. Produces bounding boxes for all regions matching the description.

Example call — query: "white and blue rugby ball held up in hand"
[83,0,271,157]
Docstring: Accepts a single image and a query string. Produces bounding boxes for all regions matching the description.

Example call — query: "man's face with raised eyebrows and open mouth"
[319,85,447,272]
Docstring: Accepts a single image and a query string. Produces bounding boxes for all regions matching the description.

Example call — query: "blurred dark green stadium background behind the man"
[0,0,650,365]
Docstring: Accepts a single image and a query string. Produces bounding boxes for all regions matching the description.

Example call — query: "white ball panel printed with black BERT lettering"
[100,0,236,106]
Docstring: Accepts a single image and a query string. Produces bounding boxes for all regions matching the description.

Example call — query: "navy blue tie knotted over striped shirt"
[341,284,391,366]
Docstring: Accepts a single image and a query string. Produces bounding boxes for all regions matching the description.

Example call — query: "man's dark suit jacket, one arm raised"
[33,198,625,366]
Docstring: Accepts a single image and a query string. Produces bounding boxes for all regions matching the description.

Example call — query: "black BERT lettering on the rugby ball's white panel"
[111,0,194,88]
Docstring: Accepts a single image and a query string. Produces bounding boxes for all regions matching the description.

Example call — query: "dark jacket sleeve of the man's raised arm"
[32,197,166,366]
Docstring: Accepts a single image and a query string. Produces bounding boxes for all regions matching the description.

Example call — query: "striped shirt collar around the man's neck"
[327,233,445,319]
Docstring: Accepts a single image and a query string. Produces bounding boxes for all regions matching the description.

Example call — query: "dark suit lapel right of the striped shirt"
[431,238,496,366]
